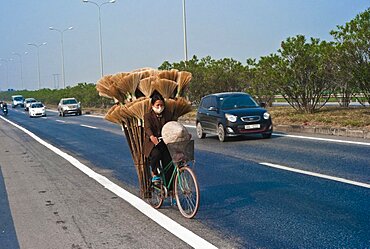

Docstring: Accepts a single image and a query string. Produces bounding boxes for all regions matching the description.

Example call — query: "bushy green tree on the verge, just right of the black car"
[278,35,333,113]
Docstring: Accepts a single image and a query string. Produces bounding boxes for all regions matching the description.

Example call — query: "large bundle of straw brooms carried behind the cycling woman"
[96,68,192,197]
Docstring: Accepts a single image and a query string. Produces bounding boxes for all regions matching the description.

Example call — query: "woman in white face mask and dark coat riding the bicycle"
[144,94,174,182]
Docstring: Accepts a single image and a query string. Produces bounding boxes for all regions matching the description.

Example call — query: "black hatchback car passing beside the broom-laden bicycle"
[196,92,272,142]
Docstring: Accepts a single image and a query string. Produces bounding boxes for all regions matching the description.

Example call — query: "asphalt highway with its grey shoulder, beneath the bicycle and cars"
[0,109,370,248]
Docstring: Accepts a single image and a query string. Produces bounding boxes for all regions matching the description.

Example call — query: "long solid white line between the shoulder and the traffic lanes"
[0,116,217,249]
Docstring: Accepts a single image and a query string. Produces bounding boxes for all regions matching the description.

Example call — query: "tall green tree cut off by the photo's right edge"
[330,8,370,105]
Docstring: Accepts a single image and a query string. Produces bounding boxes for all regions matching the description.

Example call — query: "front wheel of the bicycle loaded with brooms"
[175,166,200,219]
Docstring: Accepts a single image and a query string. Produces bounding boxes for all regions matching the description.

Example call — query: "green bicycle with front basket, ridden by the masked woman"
[148,140,200,219]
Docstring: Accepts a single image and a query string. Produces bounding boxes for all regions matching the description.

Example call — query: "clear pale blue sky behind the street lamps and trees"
[0,0,370,91]
